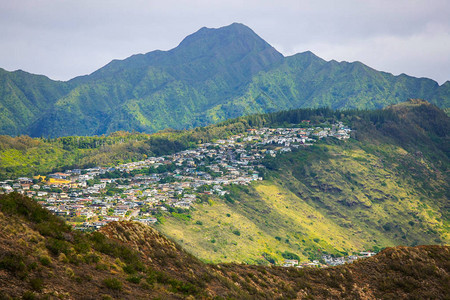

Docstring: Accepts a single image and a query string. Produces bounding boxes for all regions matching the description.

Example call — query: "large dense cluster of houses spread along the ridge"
[0,123,350,230]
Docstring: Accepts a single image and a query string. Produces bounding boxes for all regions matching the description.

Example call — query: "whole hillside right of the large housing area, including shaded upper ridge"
[157,100,450,263]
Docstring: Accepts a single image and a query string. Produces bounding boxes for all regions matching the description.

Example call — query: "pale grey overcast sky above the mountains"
[0,0,450,84]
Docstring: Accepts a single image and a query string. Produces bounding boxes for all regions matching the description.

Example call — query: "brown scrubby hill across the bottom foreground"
[0,194,450,299]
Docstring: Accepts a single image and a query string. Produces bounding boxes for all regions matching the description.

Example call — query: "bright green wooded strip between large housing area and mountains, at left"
[0,119,250,179]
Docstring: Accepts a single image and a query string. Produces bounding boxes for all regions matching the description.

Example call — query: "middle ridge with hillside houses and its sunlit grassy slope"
[3,100,449,265]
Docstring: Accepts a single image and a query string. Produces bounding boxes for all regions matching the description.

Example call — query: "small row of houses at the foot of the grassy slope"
[282,251,376,268]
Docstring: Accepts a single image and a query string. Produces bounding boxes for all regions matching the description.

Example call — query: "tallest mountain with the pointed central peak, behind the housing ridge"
[26,24,283,136]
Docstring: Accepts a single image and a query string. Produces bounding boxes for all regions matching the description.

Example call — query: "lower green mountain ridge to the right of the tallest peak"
[214,52,450,115]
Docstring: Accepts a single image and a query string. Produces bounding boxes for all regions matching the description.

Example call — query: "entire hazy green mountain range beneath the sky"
[0,23,450,137]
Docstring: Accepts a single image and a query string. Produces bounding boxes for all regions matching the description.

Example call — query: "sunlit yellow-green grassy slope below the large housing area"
[158,145,450,263]
